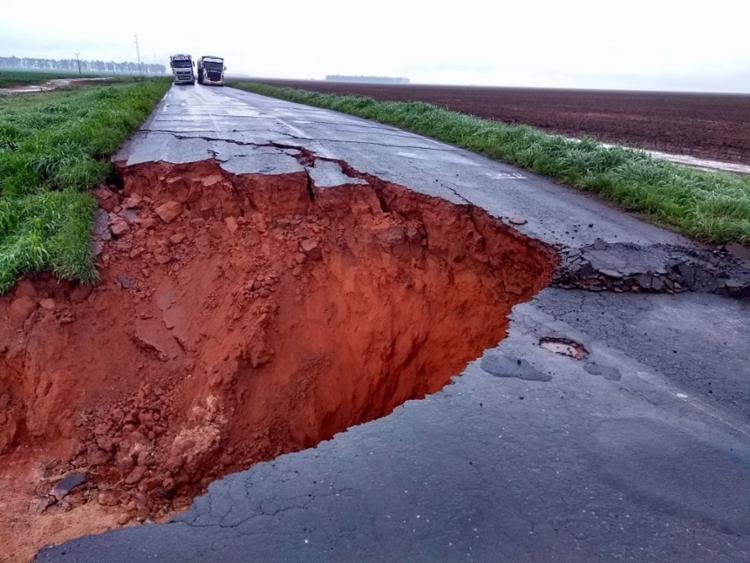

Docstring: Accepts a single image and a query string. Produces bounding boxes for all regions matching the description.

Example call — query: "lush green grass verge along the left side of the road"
[0,79,169,293]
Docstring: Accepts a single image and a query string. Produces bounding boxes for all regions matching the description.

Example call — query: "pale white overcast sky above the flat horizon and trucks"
[0,0,750,92]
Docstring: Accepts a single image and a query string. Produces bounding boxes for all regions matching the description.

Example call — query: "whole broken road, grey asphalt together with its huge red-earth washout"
[0,88,750,561]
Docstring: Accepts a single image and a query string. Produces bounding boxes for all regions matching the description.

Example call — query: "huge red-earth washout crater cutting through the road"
[0,161,554,557]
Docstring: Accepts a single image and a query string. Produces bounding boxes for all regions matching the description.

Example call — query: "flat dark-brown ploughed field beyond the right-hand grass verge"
[264,80,750,164]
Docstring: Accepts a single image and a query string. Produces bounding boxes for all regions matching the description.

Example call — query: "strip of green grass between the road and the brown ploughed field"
[232,83,750,245]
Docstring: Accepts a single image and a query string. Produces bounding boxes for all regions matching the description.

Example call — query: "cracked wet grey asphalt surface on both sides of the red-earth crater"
[39,86,750,562]
